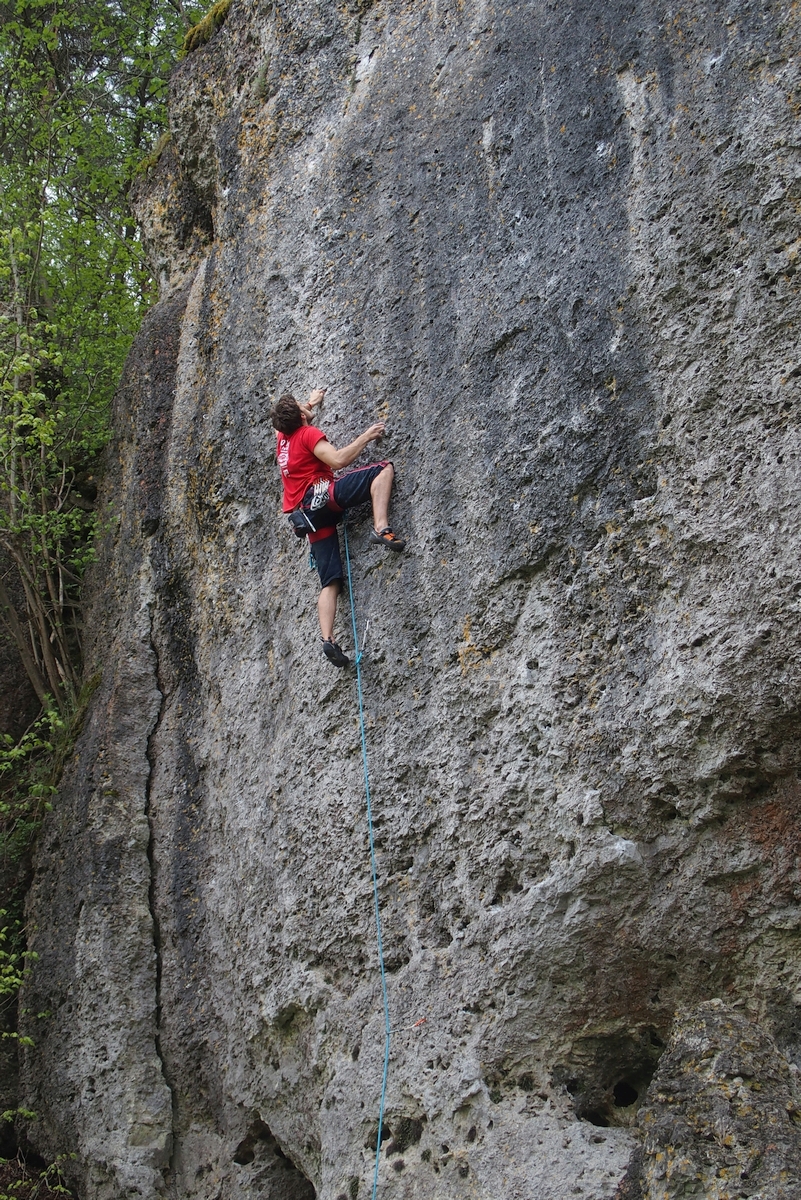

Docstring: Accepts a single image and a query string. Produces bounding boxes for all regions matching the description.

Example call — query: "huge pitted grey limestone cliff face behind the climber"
[17,0,801,1200]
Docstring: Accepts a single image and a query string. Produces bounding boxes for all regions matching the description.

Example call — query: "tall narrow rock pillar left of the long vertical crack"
[14,267,193,1200]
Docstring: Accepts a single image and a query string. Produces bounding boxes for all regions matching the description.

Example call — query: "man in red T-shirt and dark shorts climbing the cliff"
[271,388,405,667]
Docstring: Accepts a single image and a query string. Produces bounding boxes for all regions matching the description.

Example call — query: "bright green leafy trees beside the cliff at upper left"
[0,0,191,708]
